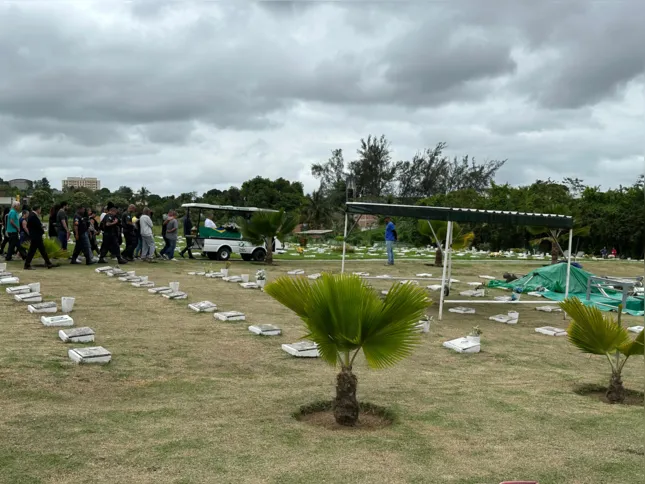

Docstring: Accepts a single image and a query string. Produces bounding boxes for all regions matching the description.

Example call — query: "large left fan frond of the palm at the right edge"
[560,298,629,355]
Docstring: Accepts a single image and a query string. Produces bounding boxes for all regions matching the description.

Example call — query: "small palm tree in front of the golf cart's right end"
[240,210,298,264]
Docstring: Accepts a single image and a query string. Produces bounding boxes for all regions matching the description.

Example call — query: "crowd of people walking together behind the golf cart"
[0,202,194,270]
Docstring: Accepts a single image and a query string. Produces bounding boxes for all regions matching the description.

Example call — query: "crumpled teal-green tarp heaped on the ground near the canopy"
[488,264,643,316]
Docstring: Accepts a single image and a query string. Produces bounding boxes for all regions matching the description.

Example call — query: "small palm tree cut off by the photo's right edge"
[560,298,643,403]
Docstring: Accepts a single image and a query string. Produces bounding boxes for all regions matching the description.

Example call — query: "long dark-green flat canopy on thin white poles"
[341,197,573,320]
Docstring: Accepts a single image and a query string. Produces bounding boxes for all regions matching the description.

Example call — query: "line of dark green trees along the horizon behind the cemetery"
[0,135,645,258]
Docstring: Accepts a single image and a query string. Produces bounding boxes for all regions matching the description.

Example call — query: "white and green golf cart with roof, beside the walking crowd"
[181,203,282,261]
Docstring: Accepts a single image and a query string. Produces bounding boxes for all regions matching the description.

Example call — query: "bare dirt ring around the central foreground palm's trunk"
[293,401,395,432]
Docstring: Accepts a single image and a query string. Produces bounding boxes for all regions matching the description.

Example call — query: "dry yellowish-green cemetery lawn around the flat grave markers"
[0,260,645,484]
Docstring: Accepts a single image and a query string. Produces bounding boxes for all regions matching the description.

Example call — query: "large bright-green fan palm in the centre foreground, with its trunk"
[265,274,430,426]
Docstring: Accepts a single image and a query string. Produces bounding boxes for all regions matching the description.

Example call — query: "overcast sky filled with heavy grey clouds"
[0,0,645,194]
